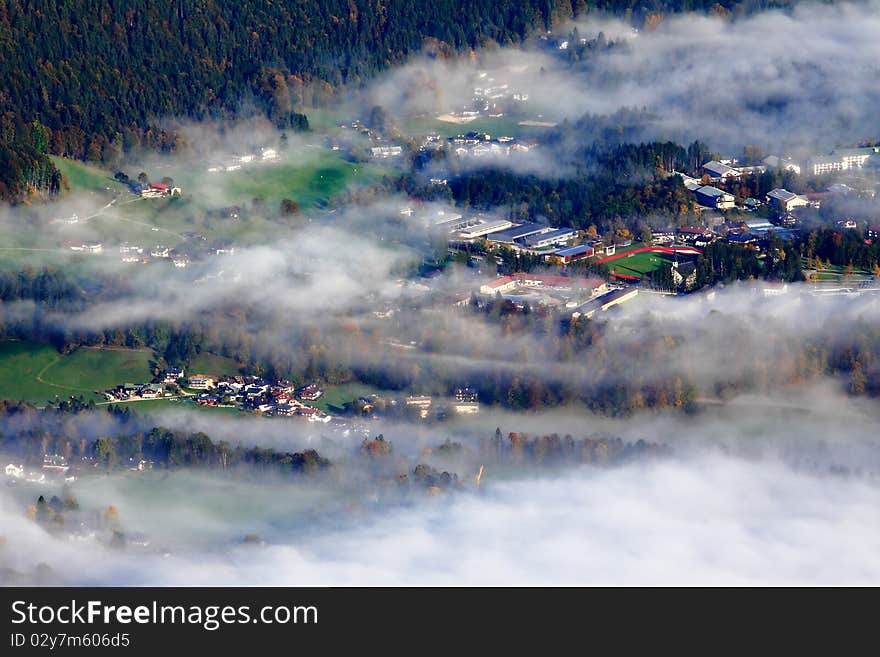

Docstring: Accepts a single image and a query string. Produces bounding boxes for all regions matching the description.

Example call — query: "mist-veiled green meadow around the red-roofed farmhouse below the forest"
[0,149,388,272]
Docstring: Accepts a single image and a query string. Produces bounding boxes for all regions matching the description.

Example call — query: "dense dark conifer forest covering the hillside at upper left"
[0,0,800,200]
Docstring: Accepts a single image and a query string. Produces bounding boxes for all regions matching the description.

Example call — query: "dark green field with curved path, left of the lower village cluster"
[0,341,152,402]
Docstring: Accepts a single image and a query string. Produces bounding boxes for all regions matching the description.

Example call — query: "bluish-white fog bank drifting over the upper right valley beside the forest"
[369,0,880,152]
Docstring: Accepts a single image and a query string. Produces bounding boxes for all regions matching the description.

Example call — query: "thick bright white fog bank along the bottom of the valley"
[2,440,880,586]
